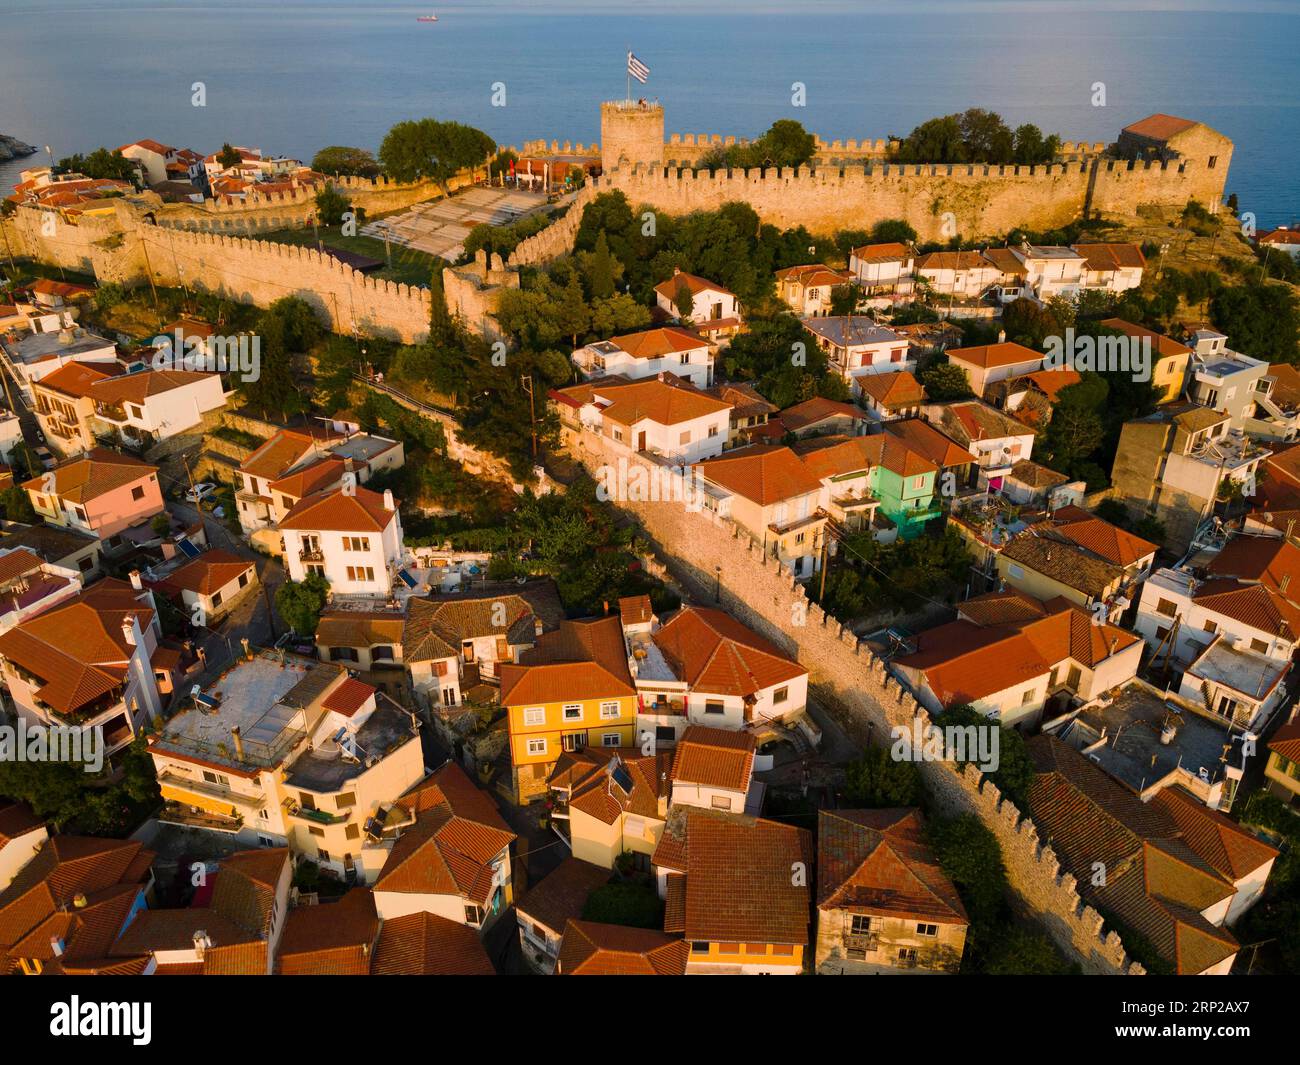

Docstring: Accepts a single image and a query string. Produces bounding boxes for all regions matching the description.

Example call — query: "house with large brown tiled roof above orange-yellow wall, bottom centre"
[653,806,813,975]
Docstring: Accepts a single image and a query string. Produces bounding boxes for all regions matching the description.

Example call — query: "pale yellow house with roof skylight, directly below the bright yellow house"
[547,746,673,873]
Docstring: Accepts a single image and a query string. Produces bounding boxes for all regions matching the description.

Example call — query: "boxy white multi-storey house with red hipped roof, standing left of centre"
[280,488,404,597]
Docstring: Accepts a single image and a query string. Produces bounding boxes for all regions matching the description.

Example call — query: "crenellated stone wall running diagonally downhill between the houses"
[571,432,1145,975]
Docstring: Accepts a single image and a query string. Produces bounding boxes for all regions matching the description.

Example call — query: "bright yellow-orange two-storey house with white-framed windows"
[501,616,637,801]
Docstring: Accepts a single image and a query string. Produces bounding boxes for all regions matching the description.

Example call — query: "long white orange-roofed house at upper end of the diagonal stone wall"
[551,375,732,463]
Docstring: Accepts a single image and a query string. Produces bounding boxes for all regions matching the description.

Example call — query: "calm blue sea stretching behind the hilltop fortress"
[0,0,1300,225]
